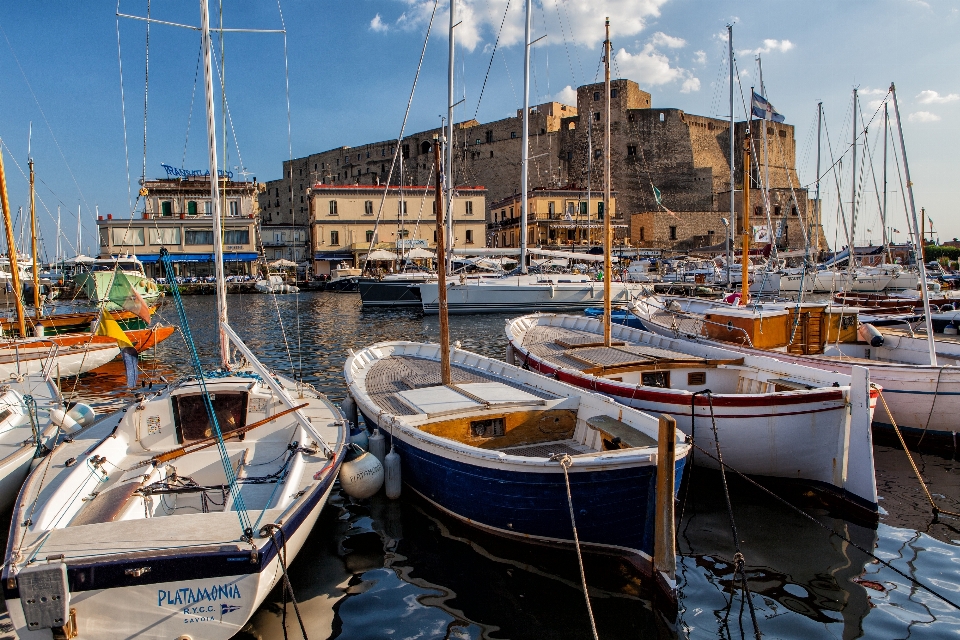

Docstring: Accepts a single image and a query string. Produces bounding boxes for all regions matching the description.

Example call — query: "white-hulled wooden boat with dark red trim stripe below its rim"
[506,314,877,518]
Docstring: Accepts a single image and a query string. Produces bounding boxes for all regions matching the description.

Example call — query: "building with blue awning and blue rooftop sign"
[97,175,263,277]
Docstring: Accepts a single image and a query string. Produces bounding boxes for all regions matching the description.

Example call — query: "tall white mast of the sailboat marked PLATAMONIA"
[200,0,230,368]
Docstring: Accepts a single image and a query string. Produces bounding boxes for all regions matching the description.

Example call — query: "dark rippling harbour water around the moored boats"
[7,292,960,640]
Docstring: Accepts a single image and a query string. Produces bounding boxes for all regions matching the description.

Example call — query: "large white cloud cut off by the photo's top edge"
[386,0,683,51]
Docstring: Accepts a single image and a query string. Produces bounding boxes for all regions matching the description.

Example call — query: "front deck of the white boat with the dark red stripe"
[523,324,704,371]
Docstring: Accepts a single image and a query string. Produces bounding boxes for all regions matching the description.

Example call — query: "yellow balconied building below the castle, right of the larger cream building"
[487,189,626,248]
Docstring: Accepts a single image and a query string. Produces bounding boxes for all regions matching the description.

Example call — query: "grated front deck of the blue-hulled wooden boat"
[366,356,560,416]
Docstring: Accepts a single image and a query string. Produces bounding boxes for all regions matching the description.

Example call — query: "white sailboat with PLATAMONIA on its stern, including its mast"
[3,0,346,640]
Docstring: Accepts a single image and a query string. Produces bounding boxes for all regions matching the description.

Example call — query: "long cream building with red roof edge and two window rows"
[305,184,487,276]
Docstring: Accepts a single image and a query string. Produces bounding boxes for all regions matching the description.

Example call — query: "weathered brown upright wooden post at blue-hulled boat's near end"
[653,415,677,591]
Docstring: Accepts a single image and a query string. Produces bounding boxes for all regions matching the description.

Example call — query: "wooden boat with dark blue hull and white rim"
[344,342,689,573]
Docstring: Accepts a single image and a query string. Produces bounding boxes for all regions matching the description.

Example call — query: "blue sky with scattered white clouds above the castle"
[0,0,960,259]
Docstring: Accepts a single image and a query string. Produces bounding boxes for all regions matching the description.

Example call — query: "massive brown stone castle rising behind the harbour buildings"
[260,79,826,258]
